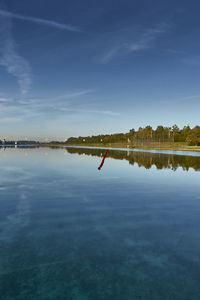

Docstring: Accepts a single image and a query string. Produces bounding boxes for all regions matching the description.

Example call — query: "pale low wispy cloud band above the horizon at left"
[0,90,120,123]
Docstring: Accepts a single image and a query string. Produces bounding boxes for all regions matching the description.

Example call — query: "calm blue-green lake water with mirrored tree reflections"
[0,148,200,300]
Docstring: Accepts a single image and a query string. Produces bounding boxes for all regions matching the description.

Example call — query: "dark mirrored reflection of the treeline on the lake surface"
[66,148,200,171]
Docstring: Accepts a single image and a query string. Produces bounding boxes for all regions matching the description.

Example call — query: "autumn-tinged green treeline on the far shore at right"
[66,125,200,146]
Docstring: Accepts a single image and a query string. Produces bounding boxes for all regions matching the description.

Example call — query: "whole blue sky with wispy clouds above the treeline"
[0,0,200,140]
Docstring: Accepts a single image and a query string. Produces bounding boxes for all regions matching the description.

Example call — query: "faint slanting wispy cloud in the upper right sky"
[100,23,168,64]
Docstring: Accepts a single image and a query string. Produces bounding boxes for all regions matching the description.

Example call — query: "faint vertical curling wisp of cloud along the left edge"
[0,10,31,95]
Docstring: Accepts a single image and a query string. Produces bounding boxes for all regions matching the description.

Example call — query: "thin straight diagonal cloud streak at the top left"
[0,10,81,32]
